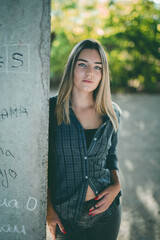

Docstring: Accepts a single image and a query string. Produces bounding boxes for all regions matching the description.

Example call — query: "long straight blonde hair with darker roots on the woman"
[56,39,121,131]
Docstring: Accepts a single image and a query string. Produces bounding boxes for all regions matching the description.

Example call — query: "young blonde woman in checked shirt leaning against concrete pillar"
[47,39,121,240]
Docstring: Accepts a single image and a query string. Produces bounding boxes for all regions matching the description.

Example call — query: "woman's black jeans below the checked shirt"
[56,198,121,240]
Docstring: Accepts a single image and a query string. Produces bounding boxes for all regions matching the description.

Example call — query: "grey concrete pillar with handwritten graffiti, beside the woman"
[0,0,50,240]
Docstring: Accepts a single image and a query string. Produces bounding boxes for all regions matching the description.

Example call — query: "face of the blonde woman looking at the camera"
[73,49,102,92]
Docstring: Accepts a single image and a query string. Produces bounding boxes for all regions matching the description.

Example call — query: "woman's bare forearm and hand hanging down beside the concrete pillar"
[47,189,66,240]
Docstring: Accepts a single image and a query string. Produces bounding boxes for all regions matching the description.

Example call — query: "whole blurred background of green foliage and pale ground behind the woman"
[48,0,160,240]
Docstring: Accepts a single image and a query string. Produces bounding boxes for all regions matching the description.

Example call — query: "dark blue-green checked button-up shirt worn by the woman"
[48,97,120,232]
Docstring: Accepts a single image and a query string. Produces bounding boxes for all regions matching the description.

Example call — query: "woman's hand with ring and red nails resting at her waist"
[89,184,120,216]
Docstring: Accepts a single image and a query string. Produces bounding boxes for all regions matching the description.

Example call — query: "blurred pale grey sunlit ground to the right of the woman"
[47,93,160,240]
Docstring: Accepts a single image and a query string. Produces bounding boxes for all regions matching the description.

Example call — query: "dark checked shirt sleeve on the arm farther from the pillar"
[106,105,121,171]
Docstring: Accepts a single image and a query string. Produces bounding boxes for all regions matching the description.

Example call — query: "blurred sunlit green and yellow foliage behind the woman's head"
[51,0,160,92]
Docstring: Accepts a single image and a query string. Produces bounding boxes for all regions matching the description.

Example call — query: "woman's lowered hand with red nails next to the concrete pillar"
[47,208,66,240]
